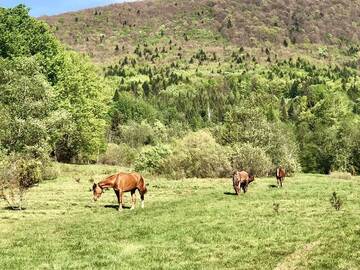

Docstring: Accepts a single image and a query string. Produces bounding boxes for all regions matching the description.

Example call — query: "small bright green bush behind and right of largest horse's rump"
[135,144,172,174]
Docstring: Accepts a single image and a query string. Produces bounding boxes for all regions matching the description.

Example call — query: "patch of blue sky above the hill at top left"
[0,0,130,17]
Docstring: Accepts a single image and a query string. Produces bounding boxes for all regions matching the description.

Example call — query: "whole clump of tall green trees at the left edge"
[0,5,109,162]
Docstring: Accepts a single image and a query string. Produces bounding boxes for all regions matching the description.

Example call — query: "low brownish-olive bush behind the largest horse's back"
[99,143,136,166]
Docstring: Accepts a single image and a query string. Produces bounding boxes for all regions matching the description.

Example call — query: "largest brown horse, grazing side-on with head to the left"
[93,172,147,211]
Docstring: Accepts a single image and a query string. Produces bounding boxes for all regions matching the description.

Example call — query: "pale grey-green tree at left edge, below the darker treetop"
[0,57,54,157]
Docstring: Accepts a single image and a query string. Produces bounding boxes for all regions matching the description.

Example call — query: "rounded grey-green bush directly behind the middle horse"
[230,143,273,177]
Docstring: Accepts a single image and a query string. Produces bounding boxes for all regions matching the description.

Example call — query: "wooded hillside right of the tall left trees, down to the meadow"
[38,0,360,177]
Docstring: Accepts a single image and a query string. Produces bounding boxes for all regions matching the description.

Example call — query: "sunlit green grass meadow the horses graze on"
[0,165,360,269]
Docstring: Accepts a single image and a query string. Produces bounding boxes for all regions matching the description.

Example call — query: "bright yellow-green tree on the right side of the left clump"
[51,53,107,162]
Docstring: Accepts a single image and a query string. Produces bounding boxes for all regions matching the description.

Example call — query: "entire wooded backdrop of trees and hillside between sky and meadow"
[0,0,360,184]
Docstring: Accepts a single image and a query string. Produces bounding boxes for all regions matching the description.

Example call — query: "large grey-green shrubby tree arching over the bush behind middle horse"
[213,108,301,174]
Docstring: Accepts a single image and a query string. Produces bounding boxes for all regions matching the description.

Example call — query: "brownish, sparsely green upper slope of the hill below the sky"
[41,0,360,65]
